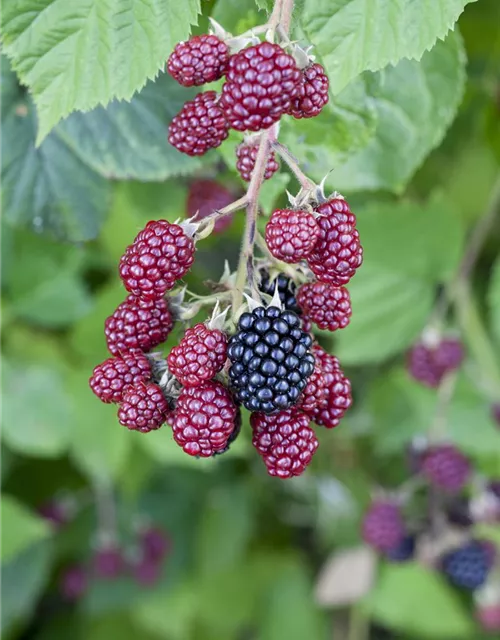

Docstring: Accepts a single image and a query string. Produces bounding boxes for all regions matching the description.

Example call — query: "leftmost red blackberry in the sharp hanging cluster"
[89,352,151,402]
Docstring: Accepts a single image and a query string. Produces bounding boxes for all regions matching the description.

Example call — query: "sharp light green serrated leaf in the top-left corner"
[2,0,200,143]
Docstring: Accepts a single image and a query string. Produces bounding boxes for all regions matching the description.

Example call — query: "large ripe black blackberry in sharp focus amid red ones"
[227,306,314,414]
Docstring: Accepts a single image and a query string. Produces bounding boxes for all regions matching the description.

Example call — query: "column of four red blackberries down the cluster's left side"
[90,220,198,433]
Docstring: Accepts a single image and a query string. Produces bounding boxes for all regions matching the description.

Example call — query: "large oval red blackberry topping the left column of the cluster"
[120,220,194,300]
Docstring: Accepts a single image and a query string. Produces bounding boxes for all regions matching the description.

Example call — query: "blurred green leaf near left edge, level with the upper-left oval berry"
[9,232,91,327]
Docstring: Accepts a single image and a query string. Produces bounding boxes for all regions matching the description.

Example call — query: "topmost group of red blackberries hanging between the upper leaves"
[167,35,329,175]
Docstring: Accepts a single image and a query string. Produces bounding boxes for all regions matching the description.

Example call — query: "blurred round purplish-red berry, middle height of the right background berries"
[422,444,471,493]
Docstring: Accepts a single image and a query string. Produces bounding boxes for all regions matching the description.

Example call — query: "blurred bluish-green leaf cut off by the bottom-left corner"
[0,540,52,637]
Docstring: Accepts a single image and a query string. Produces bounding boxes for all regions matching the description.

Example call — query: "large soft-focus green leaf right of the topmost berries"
[292,33,465,193]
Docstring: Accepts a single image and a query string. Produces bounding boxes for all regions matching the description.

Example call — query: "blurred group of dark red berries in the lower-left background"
[60,527,171,601]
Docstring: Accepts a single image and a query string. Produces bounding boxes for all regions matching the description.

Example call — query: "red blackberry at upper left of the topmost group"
[167,35,229,87]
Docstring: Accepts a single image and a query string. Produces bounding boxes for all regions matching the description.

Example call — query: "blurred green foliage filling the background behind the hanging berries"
[0,0,500,640]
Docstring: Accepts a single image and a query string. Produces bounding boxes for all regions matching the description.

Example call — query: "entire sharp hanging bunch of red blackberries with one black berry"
[90,23,356,478]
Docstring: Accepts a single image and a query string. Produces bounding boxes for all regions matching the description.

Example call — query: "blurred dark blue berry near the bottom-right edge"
[441,540,491,591]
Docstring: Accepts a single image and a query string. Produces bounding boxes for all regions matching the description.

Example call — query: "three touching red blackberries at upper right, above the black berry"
[266,196,363,331]
